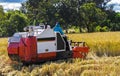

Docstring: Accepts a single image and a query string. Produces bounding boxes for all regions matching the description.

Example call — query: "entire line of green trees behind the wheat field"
[0,0,120,36]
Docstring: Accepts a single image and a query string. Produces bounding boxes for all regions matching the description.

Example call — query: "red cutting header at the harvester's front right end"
[73,46,89,58]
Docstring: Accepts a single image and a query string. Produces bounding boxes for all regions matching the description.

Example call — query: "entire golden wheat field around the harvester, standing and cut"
[0,32,120,76]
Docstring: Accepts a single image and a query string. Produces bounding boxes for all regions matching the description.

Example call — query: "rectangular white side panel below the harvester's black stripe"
[37,41,56,53]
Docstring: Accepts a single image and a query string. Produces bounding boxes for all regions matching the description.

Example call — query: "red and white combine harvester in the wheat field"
[8,25,89,63]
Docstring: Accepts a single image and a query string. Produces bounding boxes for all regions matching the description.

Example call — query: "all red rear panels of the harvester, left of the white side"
[8,37,37,62]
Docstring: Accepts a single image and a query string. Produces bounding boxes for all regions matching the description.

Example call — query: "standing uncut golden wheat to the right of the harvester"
[68,32,120,56]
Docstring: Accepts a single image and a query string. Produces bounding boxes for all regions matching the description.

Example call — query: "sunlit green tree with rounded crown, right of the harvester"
[80,3,107,32]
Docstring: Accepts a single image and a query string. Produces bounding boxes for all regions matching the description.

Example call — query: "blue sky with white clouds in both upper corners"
[0,0,120,12]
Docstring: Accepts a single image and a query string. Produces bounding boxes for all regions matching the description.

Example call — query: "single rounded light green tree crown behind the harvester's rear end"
[8,13,27,35]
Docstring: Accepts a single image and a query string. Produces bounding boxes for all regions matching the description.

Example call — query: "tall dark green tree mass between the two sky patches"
[21,0,114,32]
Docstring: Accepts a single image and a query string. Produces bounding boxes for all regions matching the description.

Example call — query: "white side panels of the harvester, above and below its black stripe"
[37,28,56,53]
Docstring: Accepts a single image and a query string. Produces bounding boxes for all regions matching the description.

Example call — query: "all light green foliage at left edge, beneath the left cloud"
[0,11,27,37]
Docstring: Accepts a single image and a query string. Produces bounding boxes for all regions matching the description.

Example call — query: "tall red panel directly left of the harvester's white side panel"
[21,37,37,61]
